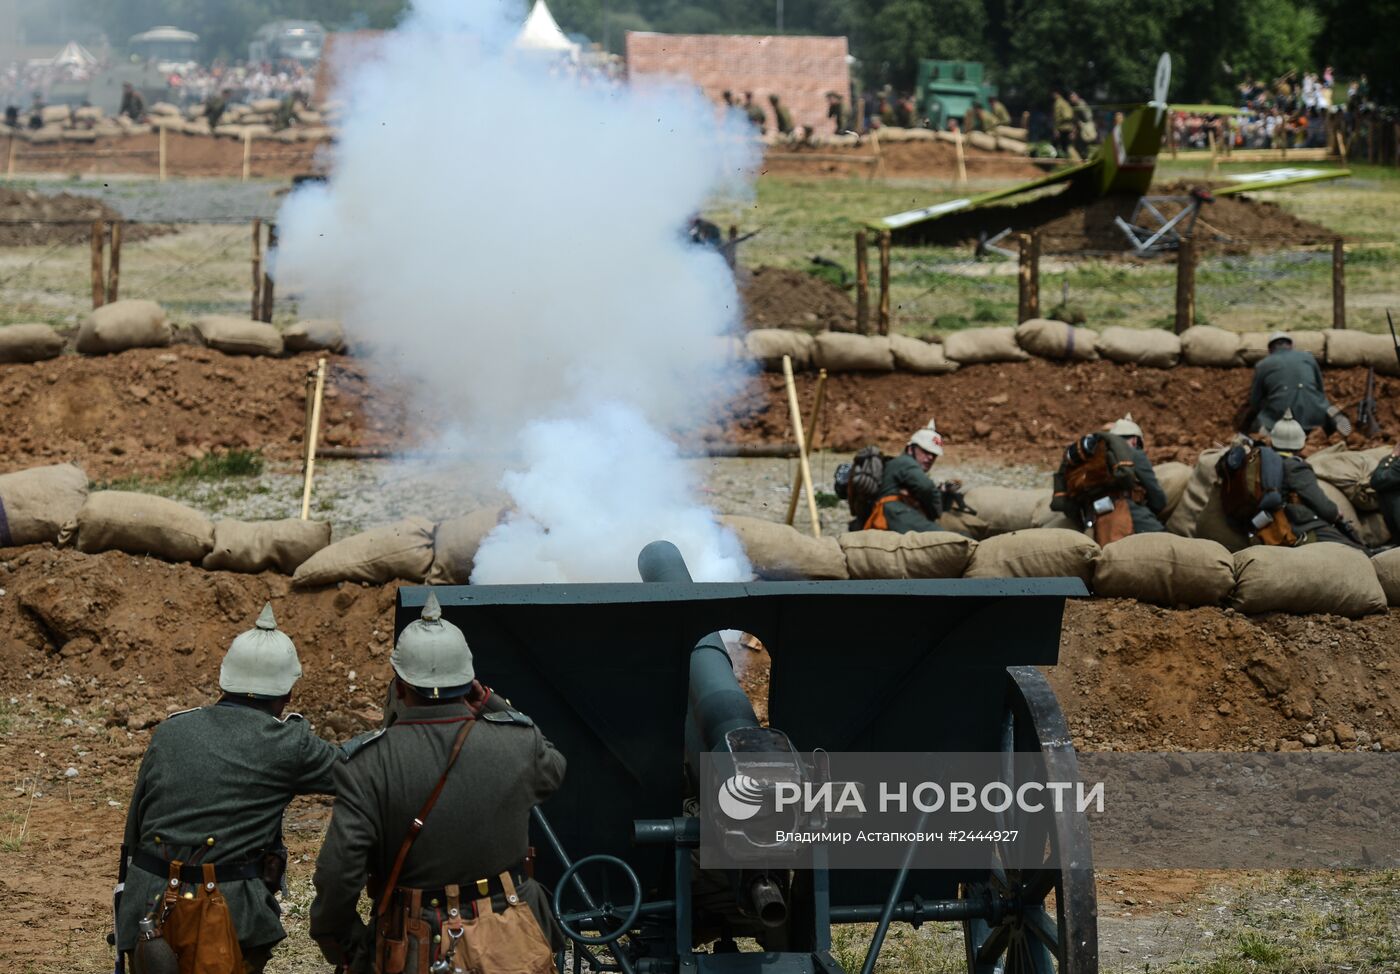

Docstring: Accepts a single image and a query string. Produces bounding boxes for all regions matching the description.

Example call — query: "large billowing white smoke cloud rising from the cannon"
[277,0,756,582]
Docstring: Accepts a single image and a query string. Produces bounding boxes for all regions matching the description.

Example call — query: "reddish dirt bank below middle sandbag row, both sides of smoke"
[0,344,1400,479]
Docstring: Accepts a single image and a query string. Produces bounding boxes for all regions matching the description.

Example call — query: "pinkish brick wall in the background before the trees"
[626,31,850,133]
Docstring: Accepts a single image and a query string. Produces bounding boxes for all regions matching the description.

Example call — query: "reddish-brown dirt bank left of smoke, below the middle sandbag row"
[0,346,407,479]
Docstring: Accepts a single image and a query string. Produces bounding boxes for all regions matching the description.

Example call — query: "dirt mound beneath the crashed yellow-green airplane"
[896,183,1337,253]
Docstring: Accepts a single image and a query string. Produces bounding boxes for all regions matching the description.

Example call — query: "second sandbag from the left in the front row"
[77,490,214,564]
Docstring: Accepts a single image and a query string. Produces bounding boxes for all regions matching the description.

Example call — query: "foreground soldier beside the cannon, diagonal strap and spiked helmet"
[311,593,564,971]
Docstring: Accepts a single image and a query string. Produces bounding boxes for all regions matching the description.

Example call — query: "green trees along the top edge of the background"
[13,0,1400,106]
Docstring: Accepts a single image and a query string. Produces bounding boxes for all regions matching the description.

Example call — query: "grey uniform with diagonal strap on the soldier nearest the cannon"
[311,698,564,971]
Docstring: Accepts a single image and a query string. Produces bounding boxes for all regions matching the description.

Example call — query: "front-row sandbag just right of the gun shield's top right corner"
[1093,532,1235,606]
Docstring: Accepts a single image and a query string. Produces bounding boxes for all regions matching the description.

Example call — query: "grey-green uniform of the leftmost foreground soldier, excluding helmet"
[116,700,344,950]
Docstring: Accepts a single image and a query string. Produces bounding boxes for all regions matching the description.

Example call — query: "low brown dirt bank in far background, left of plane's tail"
[763,141,1044,179]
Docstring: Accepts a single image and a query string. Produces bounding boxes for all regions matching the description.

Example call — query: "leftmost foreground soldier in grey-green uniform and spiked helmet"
[116,605,344,974]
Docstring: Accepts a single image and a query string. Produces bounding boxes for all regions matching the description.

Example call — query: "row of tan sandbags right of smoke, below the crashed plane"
[743,318,1400,376]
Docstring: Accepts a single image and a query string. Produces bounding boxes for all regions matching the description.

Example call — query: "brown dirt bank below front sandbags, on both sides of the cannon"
[0,547,1400,750]
